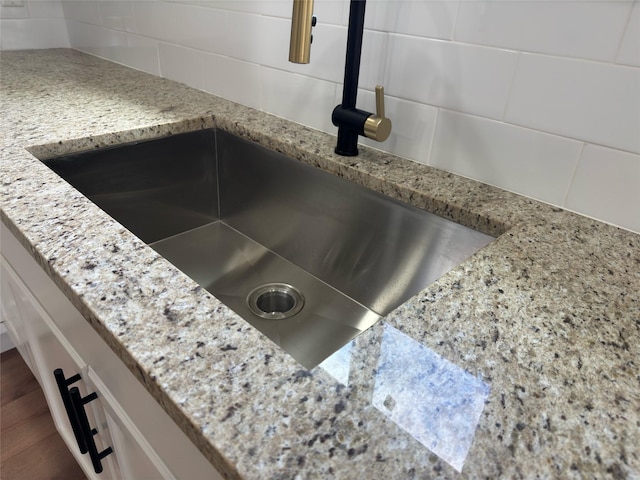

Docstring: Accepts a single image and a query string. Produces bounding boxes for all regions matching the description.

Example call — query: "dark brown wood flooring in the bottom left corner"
[0,348,86,480]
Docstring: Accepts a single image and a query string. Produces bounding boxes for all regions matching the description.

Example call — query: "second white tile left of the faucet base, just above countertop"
[204,54,260,109]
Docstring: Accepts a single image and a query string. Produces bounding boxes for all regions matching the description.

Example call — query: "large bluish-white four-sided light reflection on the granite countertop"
[373,325,490,472]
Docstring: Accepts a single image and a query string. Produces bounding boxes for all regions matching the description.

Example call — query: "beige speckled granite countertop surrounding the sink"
[0,50,640,479]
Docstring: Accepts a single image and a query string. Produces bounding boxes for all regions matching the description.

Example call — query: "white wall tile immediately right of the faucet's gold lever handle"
[386,35,517,119]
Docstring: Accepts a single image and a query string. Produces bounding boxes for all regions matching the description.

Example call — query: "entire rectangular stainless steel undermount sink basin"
[44,130,493,368]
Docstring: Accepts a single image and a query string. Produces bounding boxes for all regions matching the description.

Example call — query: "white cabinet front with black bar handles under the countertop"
[1,224,222,480]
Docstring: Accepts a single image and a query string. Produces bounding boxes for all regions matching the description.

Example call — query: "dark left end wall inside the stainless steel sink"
[45,130,218,243]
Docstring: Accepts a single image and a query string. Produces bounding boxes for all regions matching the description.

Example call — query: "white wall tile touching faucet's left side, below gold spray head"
[261,67,337,132]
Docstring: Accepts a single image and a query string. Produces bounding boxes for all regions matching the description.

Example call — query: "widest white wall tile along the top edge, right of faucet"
[454,0,632,61]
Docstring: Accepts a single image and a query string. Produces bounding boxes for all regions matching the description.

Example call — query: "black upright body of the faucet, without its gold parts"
[331,0,372,156]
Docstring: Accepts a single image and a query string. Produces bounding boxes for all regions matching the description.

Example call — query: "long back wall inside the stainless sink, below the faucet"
[218,134,493,315]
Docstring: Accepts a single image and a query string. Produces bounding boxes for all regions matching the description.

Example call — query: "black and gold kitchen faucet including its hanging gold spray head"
[289,0,391,156]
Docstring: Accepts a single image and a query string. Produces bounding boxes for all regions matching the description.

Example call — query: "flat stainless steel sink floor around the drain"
[151,222,380,368]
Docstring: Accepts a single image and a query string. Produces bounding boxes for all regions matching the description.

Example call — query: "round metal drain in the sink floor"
[247,283,304,320]
